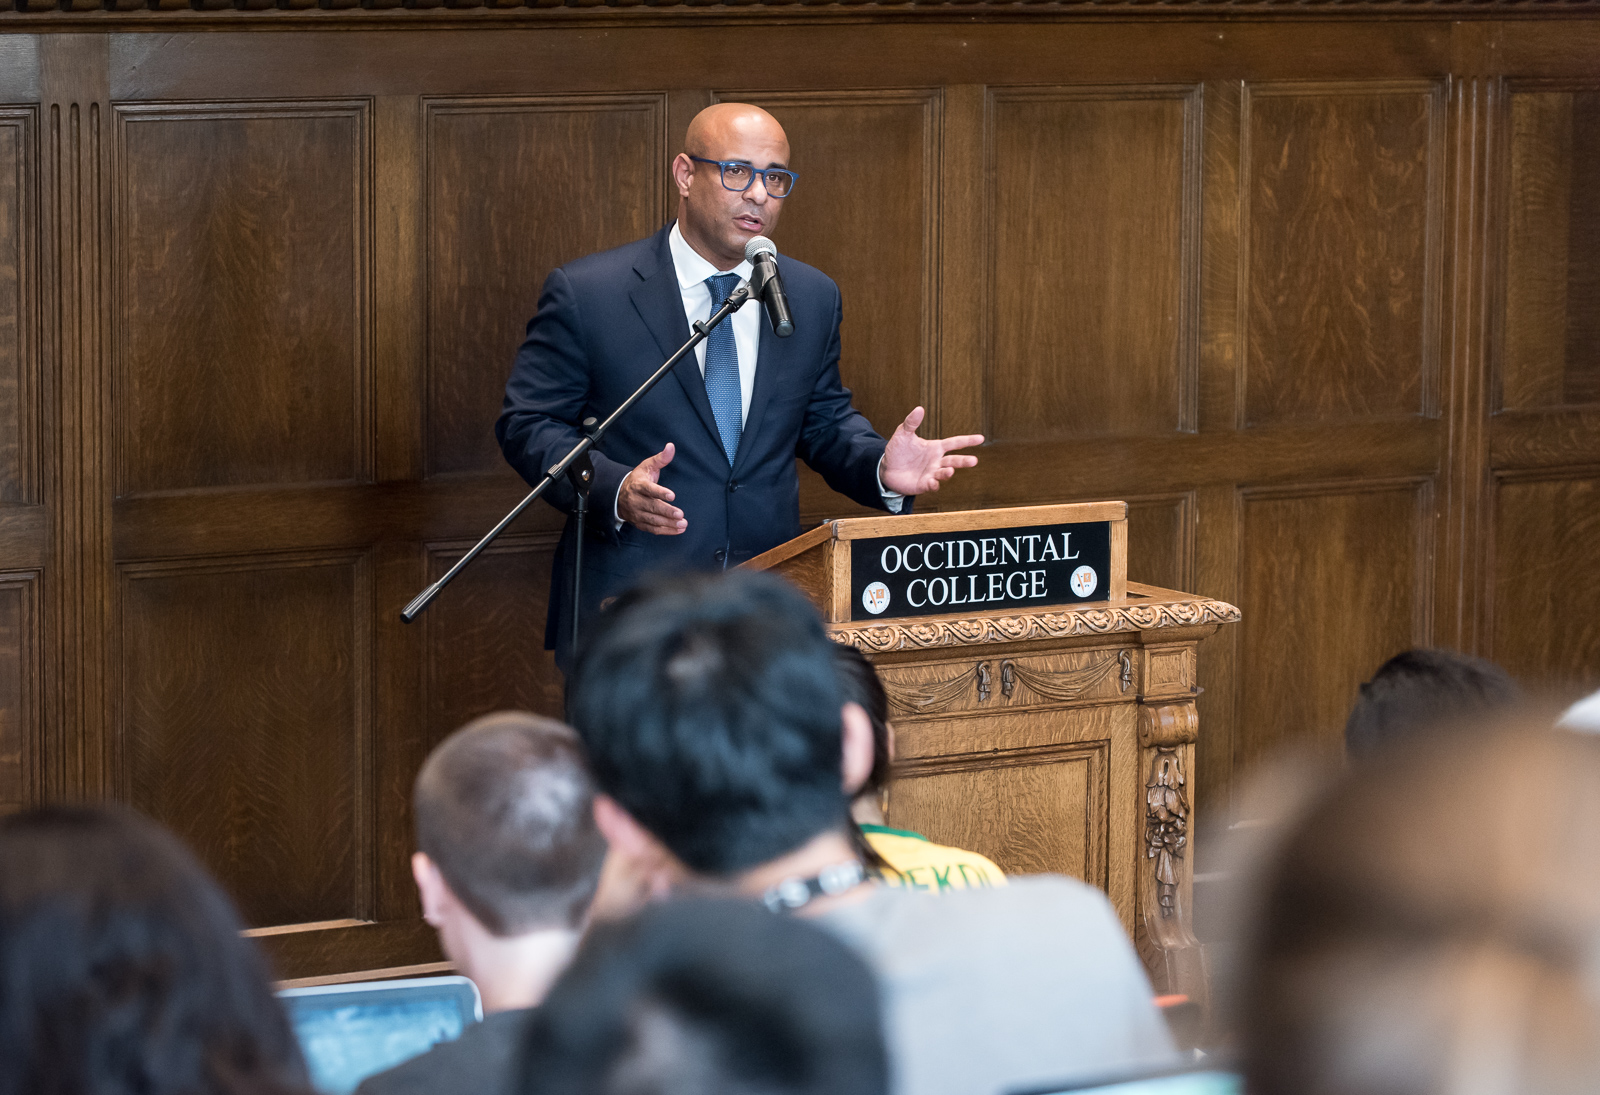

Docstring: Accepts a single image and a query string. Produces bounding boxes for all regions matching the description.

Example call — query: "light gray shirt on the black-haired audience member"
[818,876,1178,1095]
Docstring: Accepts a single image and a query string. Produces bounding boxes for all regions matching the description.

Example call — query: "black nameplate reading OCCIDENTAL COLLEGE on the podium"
[850,520,1110,621]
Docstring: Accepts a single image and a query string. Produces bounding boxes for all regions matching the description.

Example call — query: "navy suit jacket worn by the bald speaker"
[494,226,910,671]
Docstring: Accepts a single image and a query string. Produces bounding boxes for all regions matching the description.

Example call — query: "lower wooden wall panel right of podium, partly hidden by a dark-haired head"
[1234,480,1432,765]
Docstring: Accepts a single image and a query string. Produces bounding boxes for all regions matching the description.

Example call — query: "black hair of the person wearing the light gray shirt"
[568,572,848,876]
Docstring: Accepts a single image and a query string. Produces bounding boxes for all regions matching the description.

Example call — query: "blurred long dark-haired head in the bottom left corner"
[0,807,307,1095]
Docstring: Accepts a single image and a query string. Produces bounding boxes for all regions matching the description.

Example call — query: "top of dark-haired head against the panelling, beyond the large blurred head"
[1344,650,1522,760]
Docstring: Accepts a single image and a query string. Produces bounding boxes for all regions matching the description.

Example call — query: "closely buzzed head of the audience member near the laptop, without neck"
[414,711,605,937]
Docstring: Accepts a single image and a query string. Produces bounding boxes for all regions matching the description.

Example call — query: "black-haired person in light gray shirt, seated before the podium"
[568,572,1173,1095]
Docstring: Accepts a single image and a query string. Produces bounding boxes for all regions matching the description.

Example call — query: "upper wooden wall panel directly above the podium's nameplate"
[984,88,1198,442]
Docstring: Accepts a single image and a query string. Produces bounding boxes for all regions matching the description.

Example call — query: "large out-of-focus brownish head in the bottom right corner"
[1240,727,1600,1095]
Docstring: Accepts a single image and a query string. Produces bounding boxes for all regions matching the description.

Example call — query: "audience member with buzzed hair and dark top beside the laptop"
[357,711,605,1095]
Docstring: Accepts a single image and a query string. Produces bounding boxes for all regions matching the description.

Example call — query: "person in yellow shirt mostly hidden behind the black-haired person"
[834,644,1005,893]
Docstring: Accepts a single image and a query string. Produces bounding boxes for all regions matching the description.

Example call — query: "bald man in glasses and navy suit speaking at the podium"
[494,102,984,672]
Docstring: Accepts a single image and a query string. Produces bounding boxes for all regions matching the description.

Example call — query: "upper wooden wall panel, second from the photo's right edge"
[1240,83,1443,426]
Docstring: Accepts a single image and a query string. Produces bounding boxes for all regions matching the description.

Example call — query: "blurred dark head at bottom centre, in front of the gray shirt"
[523,900,888,1095]
